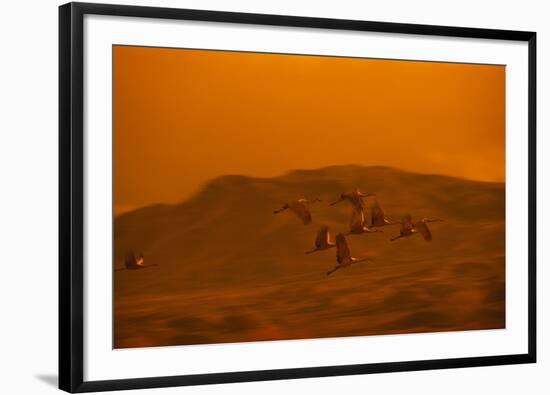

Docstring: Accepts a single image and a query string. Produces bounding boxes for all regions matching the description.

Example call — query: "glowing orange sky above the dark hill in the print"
[113,46,505,217]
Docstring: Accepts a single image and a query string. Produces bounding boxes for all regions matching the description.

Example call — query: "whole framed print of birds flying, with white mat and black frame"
[59,3,536,392]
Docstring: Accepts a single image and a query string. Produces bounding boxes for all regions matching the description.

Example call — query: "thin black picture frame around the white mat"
[59,3,536,392]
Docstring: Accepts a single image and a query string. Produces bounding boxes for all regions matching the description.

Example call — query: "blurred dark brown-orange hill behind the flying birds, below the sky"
[114,166,505,348]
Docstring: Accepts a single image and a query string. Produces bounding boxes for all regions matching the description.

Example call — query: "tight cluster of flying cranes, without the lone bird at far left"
[273,189,443,275]
